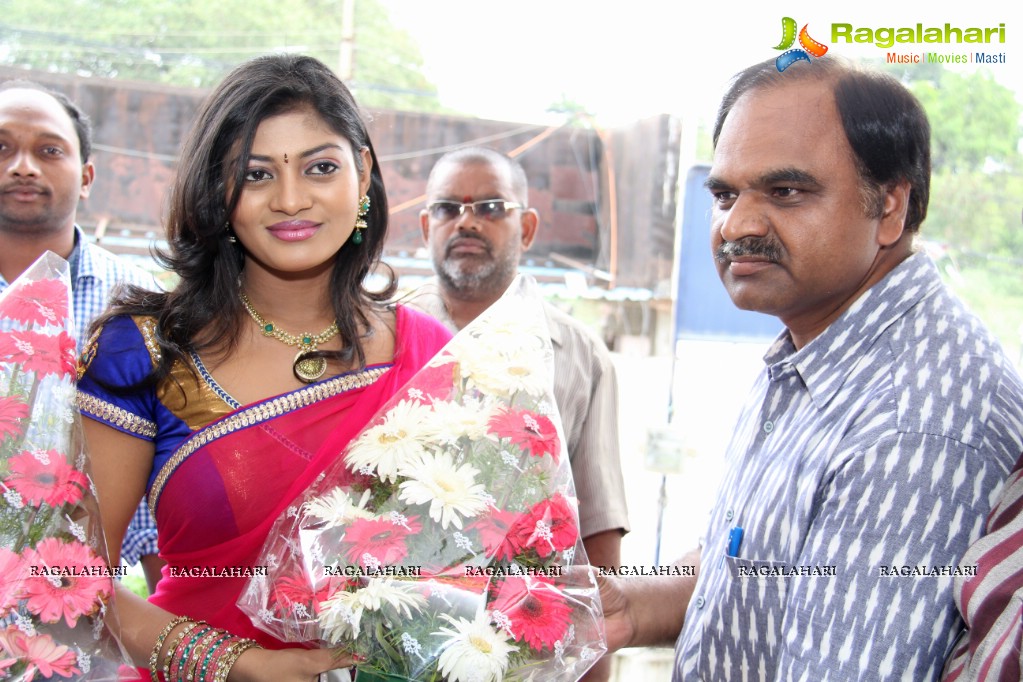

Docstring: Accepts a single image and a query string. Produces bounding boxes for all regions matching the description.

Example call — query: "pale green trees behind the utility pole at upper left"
[0,0,440,110]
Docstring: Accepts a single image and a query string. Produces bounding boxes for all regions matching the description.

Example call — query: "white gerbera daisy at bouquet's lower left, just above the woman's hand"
[317,578,427,644]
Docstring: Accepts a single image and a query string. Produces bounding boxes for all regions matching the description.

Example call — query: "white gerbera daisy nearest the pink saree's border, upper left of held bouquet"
[345,400,431,483]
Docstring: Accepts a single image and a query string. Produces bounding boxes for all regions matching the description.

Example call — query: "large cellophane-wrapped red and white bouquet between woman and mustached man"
[239,277,606,682]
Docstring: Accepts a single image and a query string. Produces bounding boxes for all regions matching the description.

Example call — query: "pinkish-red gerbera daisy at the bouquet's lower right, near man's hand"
[490,576,572,651]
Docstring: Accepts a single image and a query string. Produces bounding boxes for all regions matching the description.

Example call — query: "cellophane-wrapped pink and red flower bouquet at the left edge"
[0,252,124,681]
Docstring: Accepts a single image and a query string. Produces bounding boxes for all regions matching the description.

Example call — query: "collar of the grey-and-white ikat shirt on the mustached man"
[764,252,942,408]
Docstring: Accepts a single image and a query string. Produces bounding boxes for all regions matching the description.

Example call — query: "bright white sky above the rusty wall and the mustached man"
[383,0,1023,156]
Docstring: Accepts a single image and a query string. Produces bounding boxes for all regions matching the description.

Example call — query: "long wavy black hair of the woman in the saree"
[94,54,397,383]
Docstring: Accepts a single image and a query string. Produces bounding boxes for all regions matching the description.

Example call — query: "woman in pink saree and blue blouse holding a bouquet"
[79,55,449,682]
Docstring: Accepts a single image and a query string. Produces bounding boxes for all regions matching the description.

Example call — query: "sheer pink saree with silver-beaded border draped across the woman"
[149,307,450,648]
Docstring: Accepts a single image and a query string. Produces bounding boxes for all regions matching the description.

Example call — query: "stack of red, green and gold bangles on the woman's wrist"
[149,616,260,682]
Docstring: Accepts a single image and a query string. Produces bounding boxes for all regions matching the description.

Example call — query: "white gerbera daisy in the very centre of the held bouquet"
[398,452,487,529]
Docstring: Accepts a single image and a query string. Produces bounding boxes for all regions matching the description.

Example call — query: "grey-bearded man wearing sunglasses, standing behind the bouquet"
[408,147,628,681]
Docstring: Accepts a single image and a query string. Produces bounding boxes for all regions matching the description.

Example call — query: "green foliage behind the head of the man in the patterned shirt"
[901,65,1023,363]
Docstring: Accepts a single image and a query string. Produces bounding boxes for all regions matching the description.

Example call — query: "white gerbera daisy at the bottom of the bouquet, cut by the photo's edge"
[434,611,516,682]
